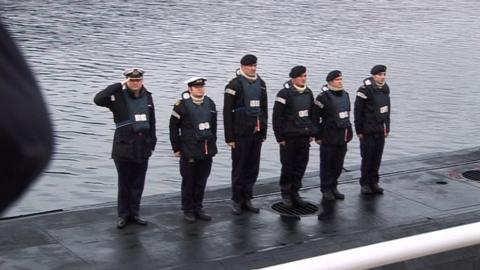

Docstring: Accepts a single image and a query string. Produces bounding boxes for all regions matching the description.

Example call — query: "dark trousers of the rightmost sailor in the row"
[360,134,385,186]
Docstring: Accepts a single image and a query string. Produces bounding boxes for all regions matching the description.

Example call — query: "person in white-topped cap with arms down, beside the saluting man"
[169,77,217,223]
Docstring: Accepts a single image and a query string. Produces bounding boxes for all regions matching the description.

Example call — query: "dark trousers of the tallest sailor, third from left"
[232,133,263,203]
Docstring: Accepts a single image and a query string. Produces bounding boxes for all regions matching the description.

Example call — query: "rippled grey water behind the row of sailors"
[0,0,480,215]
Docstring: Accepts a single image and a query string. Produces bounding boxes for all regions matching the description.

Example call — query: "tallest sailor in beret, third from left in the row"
[223,54,268,215]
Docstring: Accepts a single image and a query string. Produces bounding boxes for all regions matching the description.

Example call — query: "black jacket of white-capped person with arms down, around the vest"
[169,96,217,159]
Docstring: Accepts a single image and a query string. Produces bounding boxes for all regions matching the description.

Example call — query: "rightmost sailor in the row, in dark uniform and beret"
[354,65,390,195]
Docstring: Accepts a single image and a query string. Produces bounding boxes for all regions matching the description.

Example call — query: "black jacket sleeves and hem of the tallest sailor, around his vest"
[223,71,268,143]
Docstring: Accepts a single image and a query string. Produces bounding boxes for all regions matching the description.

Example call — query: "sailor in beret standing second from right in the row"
[315,70,353,204]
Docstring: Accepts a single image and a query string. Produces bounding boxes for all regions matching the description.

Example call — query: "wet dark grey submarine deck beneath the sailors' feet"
[0,149,480,270]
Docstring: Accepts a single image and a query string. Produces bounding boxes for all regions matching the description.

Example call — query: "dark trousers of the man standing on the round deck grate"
[280,137,310,198]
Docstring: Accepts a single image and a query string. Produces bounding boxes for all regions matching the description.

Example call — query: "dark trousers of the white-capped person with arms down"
[180,158,212,212]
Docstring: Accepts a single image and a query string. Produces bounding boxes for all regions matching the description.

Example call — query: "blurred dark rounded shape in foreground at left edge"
[0,19,53,213]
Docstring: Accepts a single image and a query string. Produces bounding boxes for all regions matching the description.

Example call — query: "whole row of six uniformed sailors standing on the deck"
[94,54,390,228]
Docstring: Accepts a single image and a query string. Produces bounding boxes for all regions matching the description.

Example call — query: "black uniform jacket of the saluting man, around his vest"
[94,83,157,162]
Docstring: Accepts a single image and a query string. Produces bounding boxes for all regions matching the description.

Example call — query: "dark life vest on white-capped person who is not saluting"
[182,92,213,141]
